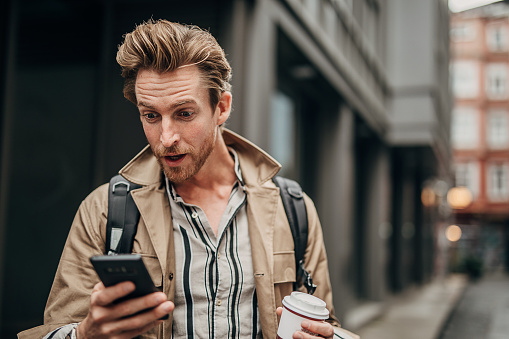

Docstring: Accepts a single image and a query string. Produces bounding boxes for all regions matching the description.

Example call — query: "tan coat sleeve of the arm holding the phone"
[18,185,108,338]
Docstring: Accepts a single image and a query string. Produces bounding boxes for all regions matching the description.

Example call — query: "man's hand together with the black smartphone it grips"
[76,255,175,339]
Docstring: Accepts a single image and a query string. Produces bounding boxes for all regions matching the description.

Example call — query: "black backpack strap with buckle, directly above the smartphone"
[106,174,141,255]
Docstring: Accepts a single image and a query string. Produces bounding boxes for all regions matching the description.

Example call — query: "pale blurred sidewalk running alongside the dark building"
[355,275,468,339]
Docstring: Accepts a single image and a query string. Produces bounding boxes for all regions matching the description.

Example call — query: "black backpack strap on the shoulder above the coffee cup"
[272,176,316,294]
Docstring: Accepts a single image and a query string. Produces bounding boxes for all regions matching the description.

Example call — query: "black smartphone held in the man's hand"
[90,254,168,319]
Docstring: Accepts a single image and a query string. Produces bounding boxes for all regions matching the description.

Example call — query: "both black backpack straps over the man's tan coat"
[106,174,316,294]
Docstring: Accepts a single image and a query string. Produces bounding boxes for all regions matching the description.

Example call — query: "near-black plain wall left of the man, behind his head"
[0,0,232,338]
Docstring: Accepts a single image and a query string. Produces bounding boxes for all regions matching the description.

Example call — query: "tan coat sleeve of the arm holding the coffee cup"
[304,195,359,339]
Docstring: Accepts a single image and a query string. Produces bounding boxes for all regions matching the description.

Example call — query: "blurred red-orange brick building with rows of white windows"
[451,2,509,276]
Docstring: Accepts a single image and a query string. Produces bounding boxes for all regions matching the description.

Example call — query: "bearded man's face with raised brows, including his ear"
[135,66,231,184]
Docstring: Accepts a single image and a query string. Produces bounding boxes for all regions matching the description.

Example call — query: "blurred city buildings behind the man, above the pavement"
[0,0,509,338]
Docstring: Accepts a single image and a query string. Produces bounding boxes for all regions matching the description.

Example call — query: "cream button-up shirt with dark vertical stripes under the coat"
[166,150,261,339]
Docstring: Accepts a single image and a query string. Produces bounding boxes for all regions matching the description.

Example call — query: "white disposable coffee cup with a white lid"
[277,292,329,339]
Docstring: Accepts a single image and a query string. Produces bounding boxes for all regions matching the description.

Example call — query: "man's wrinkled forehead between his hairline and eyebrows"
[135,65,208,100]
